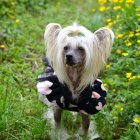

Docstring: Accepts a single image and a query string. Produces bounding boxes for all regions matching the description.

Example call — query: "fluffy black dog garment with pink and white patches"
[37,58,107,115]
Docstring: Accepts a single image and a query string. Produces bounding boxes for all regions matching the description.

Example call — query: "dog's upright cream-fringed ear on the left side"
[44,23,61,47]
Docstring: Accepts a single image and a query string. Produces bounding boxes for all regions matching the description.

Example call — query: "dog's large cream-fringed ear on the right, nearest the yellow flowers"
[94,27,114,62]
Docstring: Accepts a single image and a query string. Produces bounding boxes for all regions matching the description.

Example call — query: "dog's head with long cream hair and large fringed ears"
[44,23,114,90]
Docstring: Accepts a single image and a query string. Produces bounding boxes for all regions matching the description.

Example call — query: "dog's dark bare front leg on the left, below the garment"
[54,106,62,128]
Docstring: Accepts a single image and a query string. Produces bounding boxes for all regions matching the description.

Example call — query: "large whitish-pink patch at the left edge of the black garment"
[37,81,53,95]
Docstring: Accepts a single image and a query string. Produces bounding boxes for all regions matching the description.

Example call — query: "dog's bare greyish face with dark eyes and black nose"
[64,45,86,66]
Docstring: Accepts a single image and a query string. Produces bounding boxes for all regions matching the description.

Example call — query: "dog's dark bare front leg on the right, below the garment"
[81,113,90,134]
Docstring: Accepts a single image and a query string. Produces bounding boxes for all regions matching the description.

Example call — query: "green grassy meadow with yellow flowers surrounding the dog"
[0,0,140,140]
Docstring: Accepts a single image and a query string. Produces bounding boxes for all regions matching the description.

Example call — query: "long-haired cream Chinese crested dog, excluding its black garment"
[38,23,114,137]
